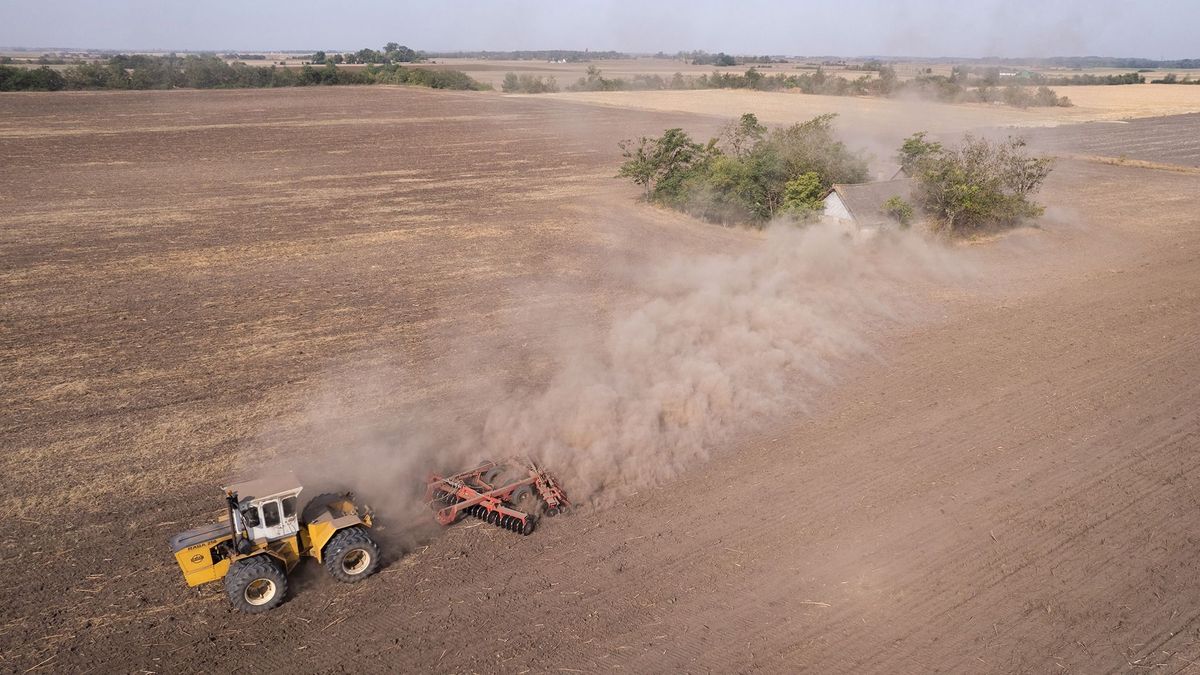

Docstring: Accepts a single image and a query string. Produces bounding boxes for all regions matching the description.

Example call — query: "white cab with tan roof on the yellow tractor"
[224,472,304,542]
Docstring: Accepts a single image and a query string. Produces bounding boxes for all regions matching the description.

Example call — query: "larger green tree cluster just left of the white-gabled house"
[618,113,868,223]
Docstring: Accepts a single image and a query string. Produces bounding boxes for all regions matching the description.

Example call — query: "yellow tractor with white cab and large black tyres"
[170,473,379,614]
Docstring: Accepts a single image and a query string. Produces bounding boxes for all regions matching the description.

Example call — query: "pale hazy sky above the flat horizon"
[0,0,1200,59]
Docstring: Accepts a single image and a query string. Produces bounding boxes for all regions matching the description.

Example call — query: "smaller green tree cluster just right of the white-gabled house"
[898,132,1052,234]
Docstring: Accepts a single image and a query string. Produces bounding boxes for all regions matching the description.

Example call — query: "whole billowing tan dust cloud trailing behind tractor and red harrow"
[276,222,972,540]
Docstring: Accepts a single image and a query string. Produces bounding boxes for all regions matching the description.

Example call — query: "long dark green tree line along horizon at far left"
[0,54,488,91]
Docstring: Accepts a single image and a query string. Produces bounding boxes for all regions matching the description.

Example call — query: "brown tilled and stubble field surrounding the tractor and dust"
[0,88,1200,673]
